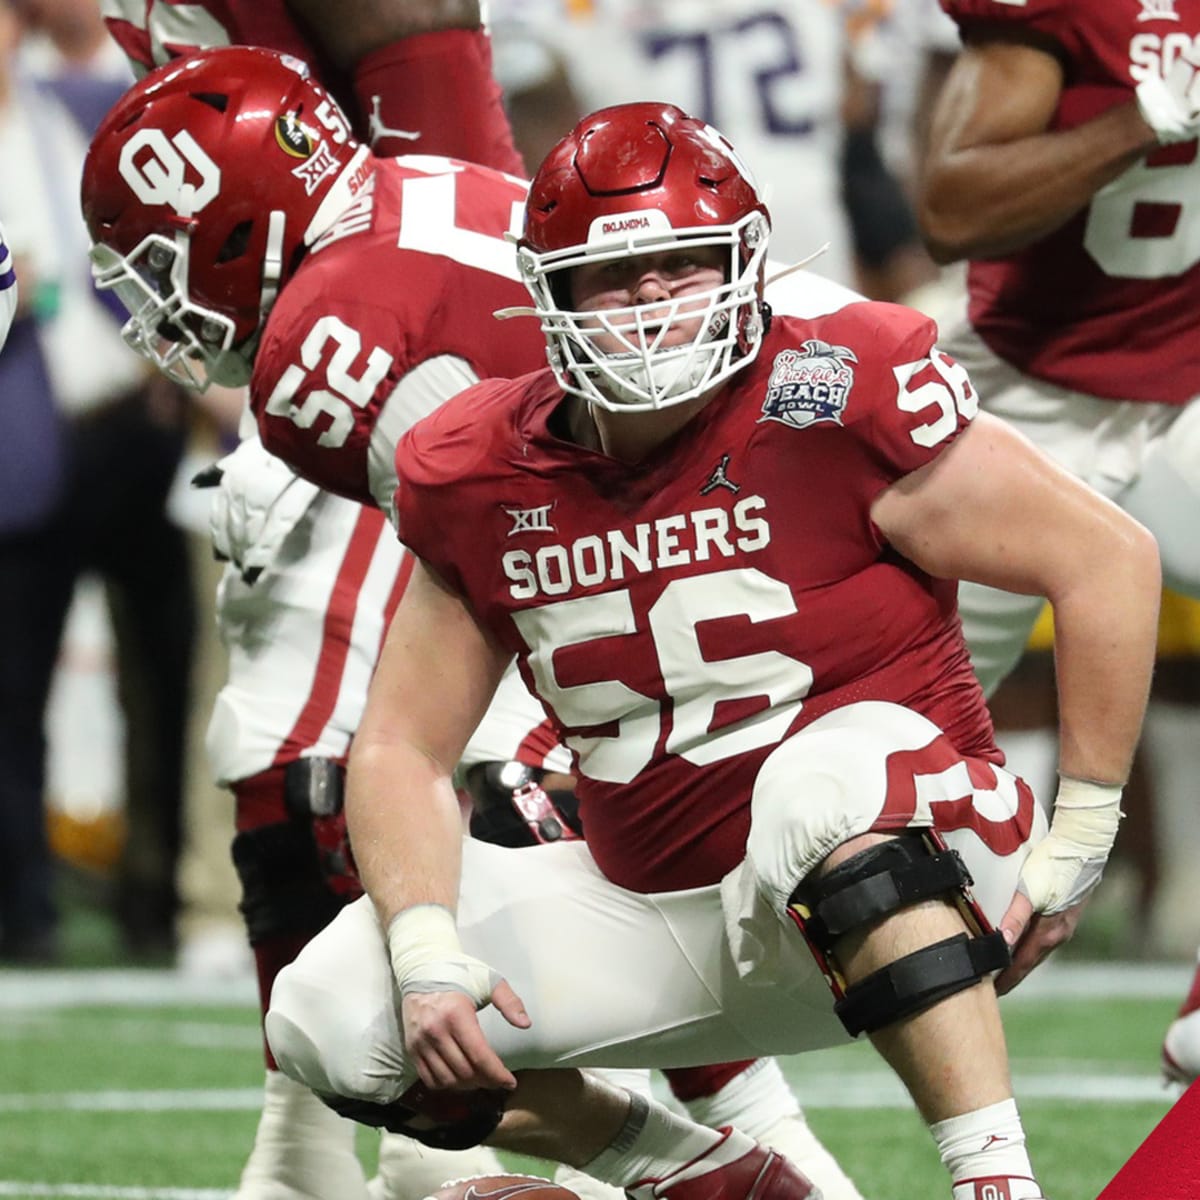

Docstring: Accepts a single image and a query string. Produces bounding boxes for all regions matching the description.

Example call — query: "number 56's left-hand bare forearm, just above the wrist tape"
[346,740,462,929]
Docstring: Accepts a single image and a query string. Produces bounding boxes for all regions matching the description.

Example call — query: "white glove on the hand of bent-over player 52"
[200,438,320,583]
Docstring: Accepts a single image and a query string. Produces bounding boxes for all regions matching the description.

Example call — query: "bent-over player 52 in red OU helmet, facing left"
[84,48,844,1200]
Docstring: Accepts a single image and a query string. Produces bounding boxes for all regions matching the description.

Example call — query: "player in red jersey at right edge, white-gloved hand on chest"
[919,0,1200,1099]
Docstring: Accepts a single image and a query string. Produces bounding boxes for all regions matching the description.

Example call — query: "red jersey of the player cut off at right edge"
[942,0,1200,404]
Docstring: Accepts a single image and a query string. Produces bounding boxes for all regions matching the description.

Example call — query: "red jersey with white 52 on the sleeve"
[251,157,546,504]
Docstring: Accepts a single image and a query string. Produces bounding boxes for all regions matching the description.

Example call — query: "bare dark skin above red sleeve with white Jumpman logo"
[287,0,480,67]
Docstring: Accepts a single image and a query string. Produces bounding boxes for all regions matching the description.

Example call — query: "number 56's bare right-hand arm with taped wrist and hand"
[872,414,1162,992]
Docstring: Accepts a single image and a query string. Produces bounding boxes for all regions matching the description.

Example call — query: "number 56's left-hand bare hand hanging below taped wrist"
[402,979,529,1090]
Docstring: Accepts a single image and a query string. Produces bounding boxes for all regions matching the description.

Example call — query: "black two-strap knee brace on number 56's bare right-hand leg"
[788,832,1012,1037]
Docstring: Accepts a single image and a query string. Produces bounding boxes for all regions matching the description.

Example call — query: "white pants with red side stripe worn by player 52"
[206,444,570,784]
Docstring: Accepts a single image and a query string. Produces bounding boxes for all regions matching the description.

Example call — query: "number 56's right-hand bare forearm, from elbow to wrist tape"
[1050,518,1162,784]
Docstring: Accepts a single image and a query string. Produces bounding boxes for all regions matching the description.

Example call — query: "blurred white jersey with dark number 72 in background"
[491,0,853,282]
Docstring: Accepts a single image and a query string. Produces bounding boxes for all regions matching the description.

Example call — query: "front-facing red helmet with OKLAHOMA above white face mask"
[517,103,770,412]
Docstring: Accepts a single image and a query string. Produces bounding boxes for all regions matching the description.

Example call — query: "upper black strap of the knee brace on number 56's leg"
[791,835,972,954]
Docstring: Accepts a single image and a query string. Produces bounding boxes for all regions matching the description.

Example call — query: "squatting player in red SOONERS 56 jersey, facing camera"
[266,104,1159,1200]
